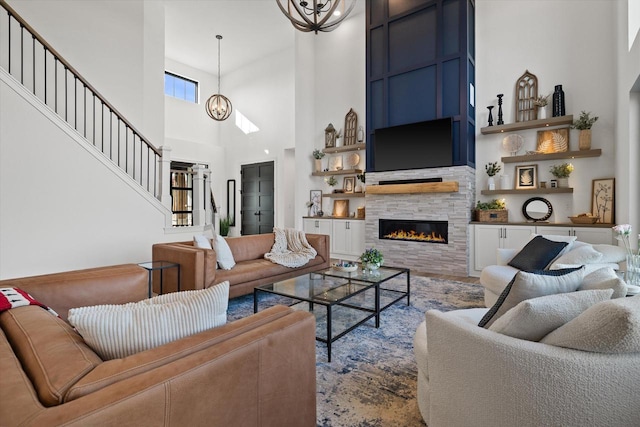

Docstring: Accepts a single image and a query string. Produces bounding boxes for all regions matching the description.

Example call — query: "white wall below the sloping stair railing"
[0,74,198,279]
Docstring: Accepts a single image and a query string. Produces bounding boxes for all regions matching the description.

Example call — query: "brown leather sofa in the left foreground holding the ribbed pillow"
[0,264,316,427]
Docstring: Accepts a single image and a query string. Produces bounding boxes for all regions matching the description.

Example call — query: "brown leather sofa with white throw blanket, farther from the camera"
[153,233,330,298]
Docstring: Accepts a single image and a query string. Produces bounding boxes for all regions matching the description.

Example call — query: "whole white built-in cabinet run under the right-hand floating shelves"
[469,224,615,277]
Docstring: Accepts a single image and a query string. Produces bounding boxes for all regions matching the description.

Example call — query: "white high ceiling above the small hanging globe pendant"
[164,0,295,75]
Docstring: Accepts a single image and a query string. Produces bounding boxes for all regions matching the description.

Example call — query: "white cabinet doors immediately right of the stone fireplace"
[471,224,536,271]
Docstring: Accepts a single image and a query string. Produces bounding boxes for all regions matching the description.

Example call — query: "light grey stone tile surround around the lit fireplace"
[365,166,475,276]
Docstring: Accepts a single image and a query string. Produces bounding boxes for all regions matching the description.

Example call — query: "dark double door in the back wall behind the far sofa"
[240,162,274,236]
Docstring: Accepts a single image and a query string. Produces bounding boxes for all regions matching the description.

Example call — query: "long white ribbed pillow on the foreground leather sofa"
[68,281,229,360]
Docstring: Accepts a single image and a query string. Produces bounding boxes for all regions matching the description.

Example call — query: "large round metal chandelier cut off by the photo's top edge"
[276,0,356,34]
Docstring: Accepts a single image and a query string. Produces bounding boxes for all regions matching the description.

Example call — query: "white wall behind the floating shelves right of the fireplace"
[476,0,619,222]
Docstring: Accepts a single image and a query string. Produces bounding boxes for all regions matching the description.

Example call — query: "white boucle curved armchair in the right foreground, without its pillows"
[414,308,640,427]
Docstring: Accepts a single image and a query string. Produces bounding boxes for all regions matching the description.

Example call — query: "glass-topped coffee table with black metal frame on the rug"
[253,267,411,362]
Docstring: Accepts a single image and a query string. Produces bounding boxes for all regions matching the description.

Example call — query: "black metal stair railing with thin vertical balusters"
[0,0,162,198]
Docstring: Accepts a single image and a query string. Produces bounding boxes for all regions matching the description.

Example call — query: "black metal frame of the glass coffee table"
[253,267,411,363]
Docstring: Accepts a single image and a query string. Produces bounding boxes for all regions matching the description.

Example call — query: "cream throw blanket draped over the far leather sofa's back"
[264,227,318,268]
